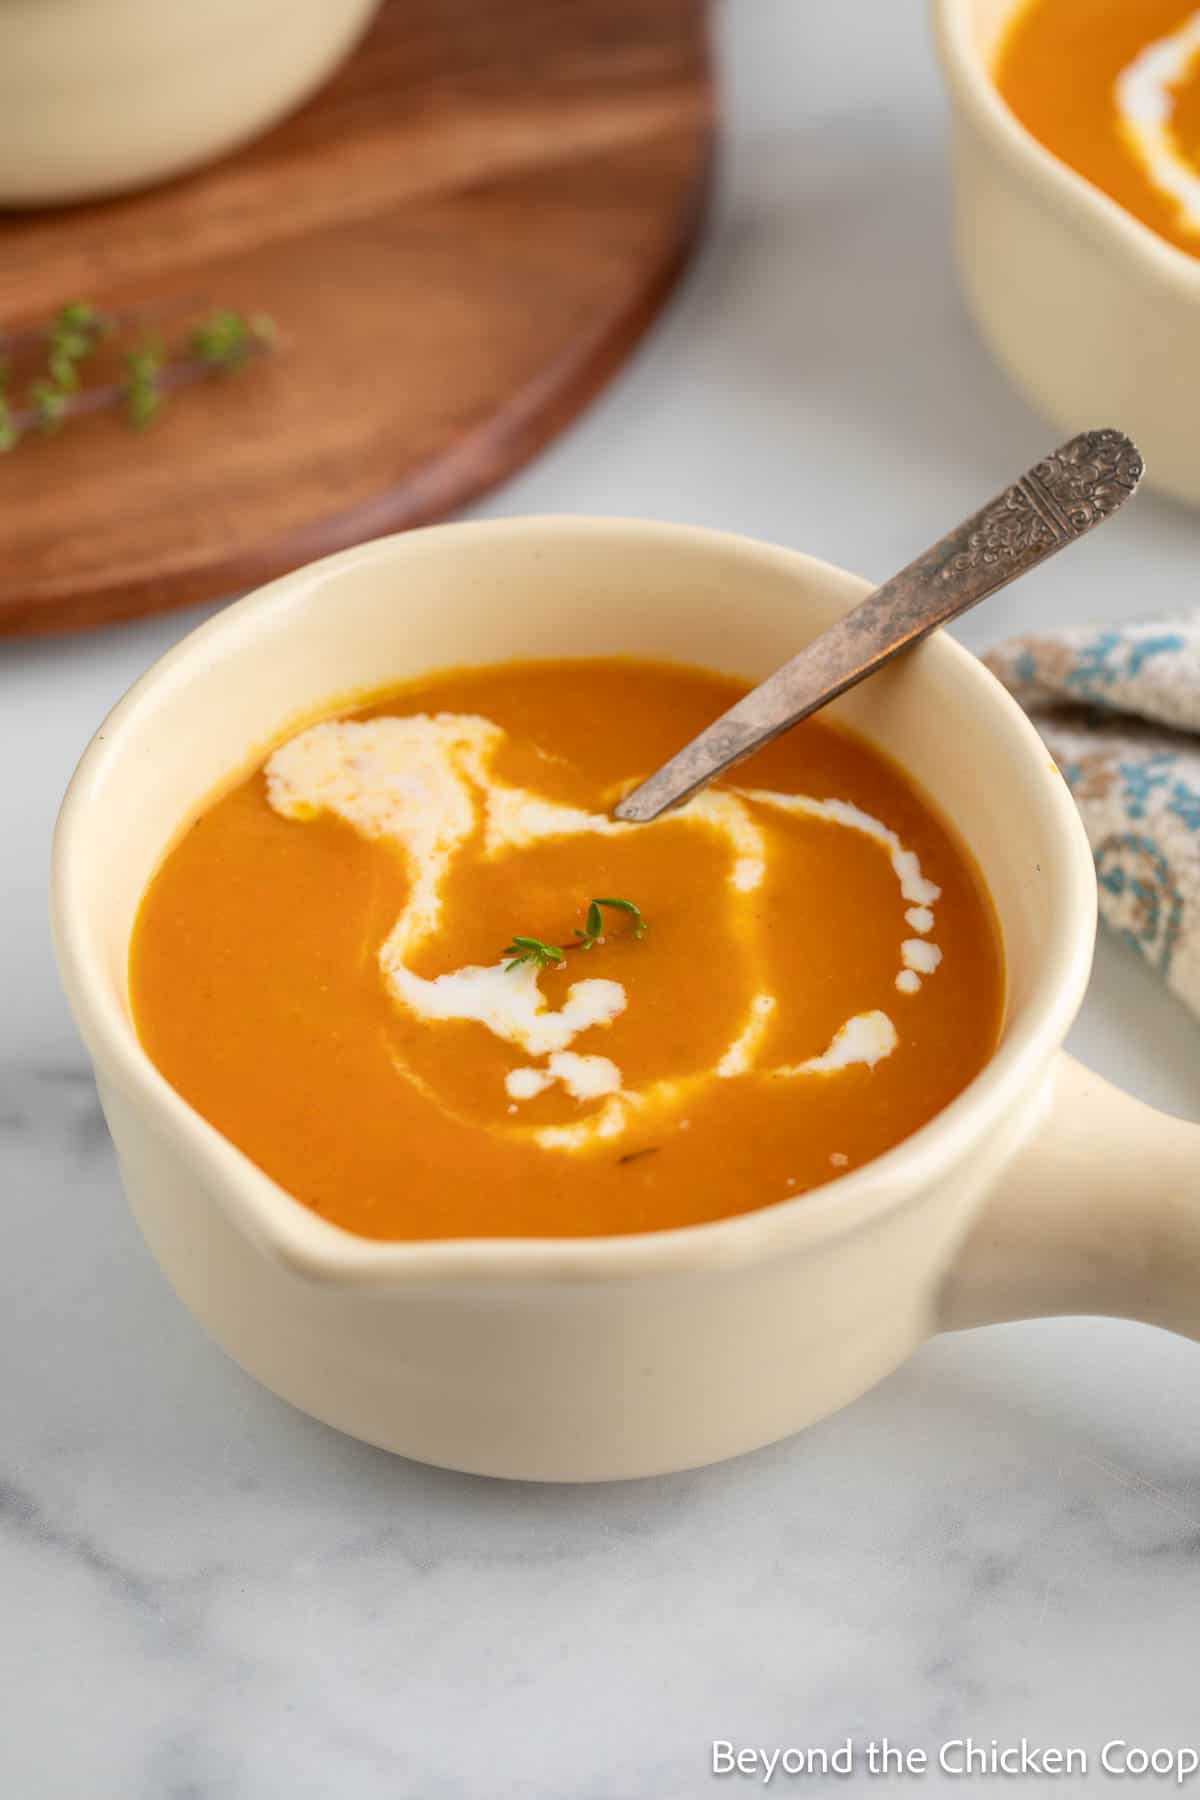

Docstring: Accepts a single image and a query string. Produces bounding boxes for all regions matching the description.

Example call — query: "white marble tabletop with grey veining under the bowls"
[0,0,1200,1800]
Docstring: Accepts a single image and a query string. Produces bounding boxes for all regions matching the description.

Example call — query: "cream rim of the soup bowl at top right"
[930,0,1200,299]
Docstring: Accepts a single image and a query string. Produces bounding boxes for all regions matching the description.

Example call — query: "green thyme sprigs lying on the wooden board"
[0,301,275,452]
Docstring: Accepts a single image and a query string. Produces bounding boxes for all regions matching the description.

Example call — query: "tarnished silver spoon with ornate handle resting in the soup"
[613,432,1144,824]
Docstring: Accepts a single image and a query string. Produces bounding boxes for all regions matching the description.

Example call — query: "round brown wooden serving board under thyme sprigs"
[0,0,712,635]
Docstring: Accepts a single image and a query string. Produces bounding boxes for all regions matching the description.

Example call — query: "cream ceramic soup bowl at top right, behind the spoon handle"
[932,0,1200,506]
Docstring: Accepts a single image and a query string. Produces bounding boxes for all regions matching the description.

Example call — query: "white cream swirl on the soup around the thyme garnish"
[266,713,941,1152]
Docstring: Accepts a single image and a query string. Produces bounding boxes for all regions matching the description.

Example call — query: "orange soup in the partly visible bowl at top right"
[995,0,1200,256]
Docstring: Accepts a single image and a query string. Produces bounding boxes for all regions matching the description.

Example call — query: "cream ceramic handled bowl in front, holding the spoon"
[52,518,1200,1480]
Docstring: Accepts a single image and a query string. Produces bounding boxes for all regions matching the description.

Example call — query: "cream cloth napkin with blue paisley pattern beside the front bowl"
[984,614,1200,1012]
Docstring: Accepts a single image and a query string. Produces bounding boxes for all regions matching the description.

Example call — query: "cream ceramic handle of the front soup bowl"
[939,1055,1200,1339]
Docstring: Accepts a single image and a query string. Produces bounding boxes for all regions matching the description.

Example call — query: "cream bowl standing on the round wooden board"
[0,0,380,207]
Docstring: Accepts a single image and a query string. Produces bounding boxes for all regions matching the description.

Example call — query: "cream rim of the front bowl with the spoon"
[50,515,1097,1289]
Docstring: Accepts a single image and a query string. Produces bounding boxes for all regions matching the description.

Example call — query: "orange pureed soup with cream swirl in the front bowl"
[130,661,1002,1238]
